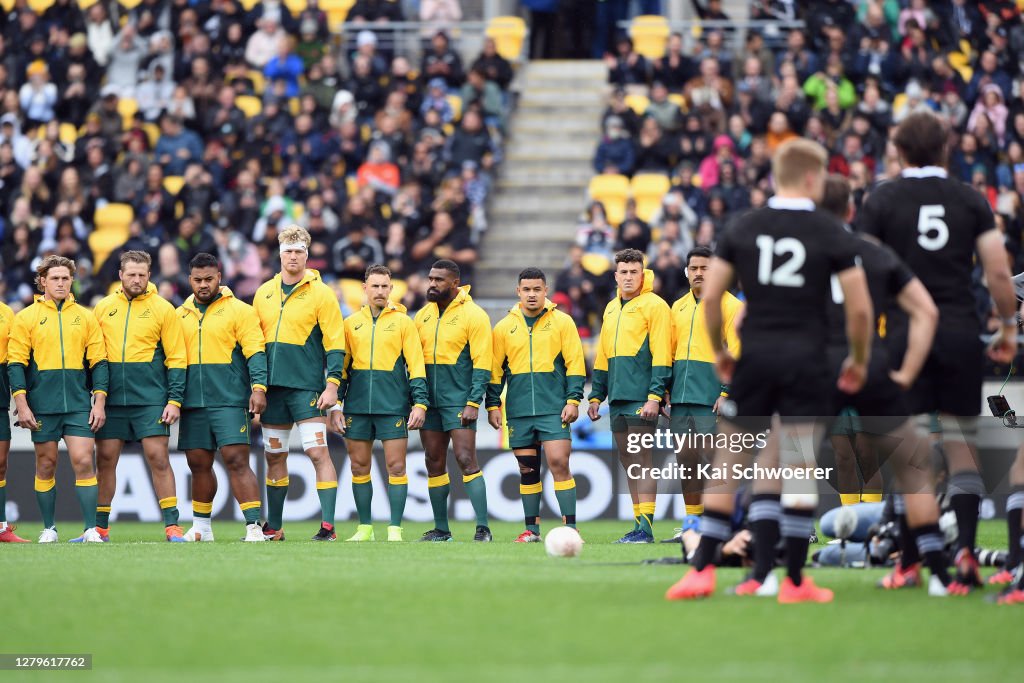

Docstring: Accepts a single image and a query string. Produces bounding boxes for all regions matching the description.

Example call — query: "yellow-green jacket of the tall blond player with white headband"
[253,269,345,391]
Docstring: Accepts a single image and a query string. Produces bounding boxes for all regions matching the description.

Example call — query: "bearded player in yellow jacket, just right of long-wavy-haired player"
[93,251,185,543]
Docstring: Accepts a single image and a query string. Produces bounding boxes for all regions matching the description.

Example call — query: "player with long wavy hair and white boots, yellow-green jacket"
[7,256,109,543]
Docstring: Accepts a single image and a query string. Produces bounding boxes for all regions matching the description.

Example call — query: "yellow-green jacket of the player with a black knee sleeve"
[486,300,587,418]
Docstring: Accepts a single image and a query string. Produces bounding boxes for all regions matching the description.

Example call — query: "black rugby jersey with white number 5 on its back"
[857,167,995,329]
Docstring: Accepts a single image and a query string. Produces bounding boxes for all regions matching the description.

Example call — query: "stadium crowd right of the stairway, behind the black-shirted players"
[573,0,1024,366]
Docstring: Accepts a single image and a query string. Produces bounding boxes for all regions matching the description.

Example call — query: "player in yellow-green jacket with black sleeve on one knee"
[486,268,587,543]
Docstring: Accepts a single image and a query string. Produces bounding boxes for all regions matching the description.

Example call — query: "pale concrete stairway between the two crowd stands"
[473,60,607,322]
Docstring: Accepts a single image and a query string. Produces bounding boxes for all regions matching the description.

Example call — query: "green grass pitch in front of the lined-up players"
[0,522,1024,683]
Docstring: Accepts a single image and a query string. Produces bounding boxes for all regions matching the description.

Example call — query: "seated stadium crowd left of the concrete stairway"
[0,0,512,308]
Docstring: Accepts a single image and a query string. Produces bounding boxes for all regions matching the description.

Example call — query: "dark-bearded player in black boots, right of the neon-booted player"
[415,259,492,543]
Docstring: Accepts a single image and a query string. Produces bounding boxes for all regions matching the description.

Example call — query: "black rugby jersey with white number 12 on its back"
[717,198,856,350]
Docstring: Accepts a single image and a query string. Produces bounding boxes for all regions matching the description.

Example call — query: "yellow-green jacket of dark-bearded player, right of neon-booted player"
[415,285,492,408]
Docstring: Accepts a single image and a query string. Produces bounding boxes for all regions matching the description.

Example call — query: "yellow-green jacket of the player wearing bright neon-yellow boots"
[338,302,428,416]
